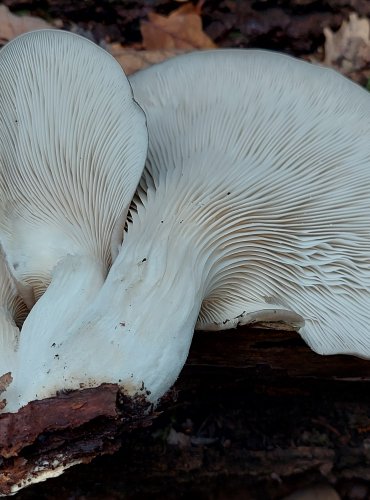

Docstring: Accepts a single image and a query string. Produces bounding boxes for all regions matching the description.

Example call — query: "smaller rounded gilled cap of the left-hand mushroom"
[0,30,147,297]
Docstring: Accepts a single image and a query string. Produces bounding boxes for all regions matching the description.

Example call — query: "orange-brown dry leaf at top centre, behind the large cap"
[140,3,215,50]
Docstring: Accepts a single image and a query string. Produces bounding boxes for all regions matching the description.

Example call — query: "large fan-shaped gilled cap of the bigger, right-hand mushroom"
[128,50,370,357]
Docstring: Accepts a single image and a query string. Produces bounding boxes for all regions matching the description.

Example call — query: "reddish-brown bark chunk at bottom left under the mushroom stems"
[0,384,154,495]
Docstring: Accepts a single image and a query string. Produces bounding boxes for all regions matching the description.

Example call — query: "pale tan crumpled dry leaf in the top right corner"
[323,13,370,75]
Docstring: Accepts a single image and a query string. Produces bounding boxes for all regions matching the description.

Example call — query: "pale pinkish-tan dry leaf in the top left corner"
[0,5,53,44]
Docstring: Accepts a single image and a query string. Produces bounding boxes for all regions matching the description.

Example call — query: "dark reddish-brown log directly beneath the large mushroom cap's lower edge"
[187,327,370,380]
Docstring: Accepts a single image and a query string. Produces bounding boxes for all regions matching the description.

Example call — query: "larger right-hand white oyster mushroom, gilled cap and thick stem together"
[5,50,370,410]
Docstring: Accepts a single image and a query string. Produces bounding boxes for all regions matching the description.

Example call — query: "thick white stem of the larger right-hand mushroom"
[84,221,204,403]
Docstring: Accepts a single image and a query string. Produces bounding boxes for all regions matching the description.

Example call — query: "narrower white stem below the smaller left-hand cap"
[5,255,106,411]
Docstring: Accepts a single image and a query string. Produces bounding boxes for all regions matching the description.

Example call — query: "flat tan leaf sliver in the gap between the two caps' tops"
[107,43,185,75]
